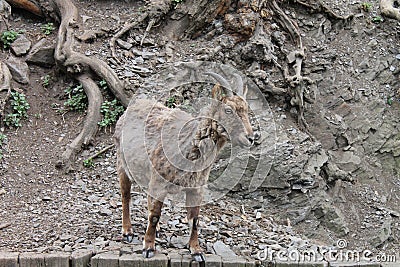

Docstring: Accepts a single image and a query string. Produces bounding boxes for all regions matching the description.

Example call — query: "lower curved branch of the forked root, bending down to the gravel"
[57,74,103,170]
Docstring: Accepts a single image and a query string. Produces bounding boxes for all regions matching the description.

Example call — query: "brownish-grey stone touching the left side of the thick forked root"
[26,39,55,67]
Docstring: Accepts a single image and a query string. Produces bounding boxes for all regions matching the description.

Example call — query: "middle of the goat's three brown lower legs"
[142,195,163,258]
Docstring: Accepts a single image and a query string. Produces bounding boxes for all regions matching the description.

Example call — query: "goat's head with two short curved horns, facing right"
[207,73,254,147]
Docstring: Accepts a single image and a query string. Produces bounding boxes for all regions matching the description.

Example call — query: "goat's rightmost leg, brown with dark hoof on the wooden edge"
[186,190,205,262]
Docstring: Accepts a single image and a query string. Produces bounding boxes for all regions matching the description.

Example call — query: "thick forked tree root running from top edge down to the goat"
[47,0,129,170]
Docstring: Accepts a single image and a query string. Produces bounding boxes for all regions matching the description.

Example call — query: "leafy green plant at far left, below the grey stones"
[4,91,30,127]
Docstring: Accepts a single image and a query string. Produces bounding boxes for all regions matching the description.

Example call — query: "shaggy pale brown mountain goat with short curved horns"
[114,72,254,262]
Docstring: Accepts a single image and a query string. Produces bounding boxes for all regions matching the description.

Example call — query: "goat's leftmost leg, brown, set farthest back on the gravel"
[118,166,133,243]
